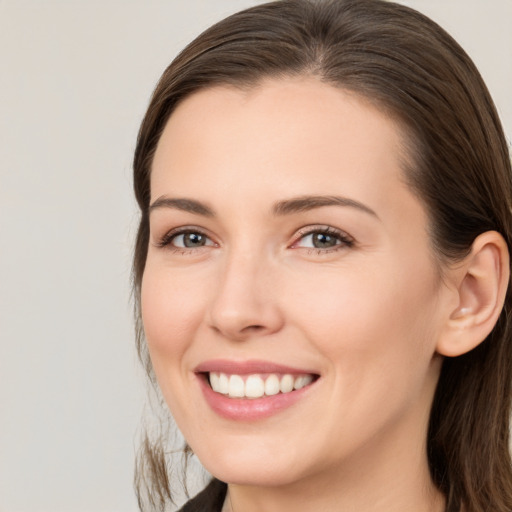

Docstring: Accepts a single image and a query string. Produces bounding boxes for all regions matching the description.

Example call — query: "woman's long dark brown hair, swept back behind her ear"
[133,0,512,512]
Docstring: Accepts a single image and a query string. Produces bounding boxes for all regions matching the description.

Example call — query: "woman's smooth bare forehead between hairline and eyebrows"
[151,78,412,210]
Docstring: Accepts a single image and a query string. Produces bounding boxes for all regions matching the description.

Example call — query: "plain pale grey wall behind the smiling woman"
[0,0,512,512]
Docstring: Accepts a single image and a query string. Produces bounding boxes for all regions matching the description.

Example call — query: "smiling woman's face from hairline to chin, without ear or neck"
[142,78,450,485]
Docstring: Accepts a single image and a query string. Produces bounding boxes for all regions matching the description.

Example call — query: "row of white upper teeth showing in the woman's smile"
[210,372,313,398]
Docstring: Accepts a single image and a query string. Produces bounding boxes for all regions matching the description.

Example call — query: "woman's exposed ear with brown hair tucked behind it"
[436,231,510,357]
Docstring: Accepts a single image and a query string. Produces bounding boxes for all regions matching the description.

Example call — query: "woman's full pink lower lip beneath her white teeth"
[197,374,316,421]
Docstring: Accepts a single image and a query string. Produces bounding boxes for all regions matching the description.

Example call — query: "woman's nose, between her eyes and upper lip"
[208,247,284,341]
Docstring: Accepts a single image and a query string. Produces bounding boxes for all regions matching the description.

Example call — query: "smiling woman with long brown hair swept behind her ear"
[134,0,512,512]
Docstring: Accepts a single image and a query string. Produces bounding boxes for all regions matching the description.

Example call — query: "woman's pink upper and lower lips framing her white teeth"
[195,360,318,421]
